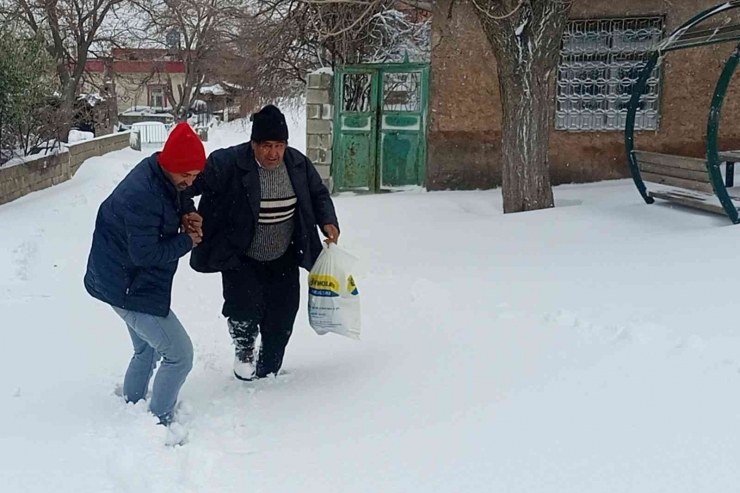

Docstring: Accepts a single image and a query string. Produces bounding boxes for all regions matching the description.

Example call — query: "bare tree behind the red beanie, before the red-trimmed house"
[125,0,245,120]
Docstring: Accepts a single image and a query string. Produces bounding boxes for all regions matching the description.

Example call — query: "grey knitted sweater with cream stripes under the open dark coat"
[247,163,297,262]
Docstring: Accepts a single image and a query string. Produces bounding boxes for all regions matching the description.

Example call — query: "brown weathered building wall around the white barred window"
[427,0,740,189]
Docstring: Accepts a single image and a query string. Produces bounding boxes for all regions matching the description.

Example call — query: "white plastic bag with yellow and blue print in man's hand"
[308,244,360,339]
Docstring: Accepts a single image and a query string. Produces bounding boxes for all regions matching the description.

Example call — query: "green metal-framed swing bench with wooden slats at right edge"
[625,0,740,224]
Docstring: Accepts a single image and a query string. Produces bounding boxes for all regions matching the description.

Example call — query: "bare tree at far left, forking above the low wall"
[0,0,125,141]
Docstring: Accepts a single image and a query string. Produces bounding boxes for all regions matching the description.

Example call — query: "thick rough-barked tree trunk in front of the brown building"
[472,0,572,213]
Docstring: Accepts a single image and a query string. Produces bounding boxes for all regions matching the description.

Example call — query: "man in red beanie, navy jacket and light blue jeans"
[85,123,206,426]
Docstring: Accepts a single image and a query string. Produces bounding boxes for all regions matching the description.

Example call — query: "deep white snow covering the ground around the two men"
[0,112,740,493]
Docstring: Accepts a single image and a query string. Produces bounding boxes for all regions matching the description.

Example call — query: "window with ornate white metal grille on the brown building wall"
[555,17,665,132]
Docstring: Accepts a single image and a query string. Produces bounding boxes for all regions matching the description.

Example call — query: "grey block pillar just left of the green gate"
[306,73,334,191]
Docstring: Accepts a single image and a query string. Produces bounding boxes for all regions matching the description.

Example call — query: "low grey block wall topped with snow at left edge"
[0,132,129,204]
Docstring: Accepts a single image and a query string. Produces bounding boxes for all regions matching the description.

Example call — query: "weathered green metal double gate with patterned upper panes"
[332,63,429,192]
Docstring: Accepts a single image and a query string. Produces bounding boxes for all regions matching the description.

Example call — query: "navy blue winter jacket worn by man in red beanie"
[85,153,193,317]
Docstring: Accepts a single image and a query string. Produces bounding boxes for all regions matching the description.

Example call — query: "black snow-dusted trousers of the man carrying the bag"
[222,246,301,378]
